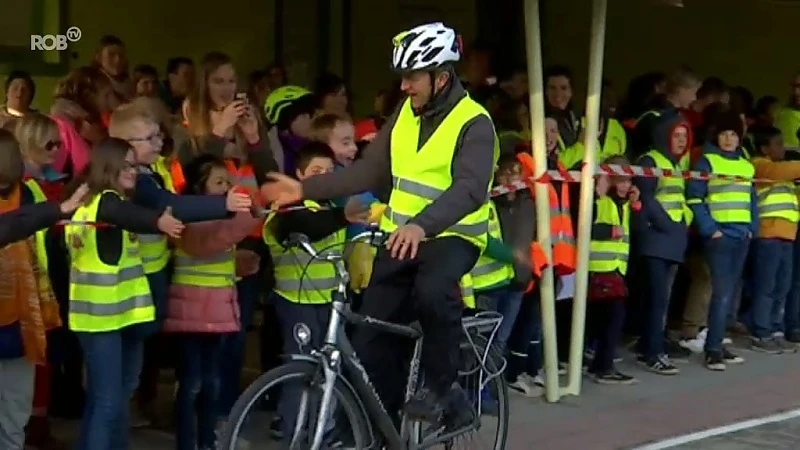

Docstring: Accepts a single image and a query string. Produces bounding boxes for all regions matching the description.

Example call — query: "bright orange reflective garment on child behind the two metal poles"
[517,153,577,275]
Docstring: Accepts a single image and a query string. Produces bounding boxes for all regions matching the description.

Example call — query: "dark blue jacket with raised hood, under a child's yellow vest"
[633,110,691,262]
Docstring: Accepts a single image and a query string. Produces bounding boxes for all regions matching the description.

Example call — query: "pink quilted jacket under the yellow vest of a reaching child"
[164,213,259,333]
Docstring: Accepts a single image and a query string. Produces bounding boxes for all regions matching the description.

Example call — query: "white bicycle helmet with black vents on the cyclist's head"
[392,22,461,73]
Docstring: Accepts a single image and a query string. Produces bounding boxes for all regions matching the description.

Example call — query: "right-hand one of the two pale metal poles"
[565,0,608,395]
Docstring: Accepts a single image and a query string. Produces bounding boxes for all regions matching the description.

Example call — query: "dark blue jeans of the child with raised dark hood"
[639,256,678,360]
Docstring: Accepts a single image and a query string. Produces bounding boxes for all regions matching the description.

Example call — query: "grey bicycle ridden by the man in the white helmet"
[220,231,509,450]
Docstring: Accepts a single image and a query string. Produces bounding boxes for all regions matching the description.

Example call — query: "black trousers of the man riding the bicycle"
[353,237,480,413]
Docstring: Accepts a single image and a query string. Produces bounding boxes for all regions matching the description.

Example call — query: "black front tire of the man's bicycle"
[219,361,372,450]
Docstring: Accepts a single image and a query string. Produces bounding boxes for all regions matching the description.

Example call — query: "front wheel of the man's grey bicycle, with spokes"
[219,361,371,450]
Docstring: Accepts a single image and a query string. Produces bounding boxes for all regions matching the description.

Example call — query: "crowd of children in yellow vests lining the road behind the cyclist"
[0,31,800,450]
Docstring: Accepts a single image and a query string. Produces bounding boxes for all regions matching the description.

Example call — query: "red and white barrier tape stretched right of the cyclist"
[491,164,775,197]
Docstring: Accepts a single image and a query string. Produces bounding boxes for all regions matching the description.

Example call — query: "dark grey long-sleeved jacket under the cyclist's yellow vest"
[303,80,495,236]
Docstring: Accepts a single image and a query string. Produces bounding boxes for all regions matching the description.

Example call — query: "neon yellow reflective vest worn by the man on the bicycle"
[380,96,500,250]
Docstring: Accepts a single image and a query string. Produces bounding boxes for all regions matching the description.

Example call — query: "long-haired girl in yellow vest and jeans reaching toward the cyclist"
[64,138,183,449]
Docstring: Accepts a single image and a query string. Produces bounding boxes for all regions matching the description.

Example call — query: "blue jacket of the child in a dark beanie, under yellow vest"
[686,143,758,239]
